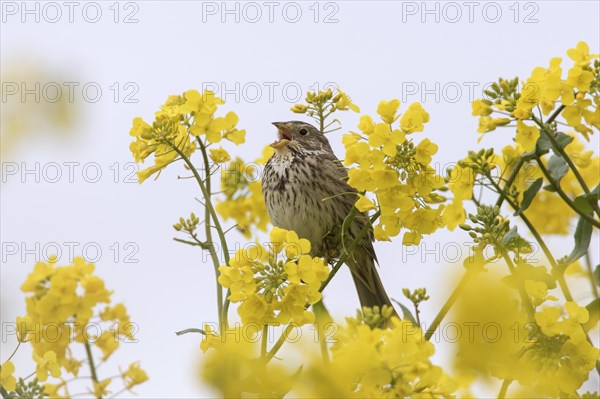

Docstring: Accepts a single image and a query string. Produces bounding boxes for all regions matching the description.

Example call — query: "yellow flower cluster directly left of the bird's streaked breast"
[215,146,273,238]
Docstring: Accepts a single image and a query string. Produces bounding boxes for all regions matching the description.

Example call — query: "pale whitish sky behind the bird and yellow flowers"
[0,1,600,397]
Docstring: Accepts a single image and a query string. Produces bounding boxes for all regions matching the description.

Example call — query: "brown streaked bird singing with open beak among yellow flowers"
[262,121,392,307]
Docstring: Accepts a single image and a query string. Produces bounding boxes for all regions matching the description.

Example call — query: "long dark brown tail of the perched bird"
[348,248,394,316]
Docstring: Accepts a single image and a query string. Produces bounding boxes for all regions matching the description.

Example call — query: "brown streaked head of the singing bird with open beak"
[271,121,331,152]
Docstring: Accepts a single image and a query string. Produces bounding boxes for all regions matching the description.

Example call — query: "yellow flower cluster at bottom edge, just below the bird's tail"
[302,317,456,398]
